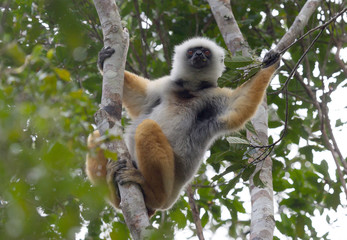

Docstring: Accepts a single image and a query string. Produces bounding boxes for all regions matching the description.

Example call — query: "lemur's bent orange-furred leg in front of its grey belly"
[135,119,175,209]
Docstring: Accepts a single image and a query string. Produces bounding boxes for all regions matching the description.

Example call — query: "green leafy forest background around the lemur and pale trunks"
[0,0,347,239]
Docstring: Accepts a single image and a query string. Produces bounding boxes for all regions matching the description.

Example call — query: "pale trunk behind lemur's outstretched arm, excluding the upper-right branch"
[208,0,275,239]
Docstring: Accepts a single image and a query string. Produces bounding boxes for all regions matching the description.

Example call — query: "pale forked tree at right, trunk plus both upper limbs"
[208,0,320,240]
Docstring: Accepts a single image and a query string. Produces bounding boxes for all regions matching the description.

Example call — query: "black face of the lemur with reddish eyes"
[186,47,212,69]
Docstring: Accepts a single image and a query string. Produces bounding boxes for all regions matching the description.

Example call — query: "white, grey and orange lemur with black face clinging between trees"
[87,37,279,215]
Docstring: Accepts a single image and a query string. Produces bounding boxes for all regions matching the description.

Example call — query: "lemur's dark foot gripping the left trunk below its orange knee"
[115,159,144,185]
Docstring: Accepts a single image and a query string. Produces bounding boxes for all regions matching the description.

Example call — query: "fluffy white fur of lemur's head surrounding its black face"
[170,37,225,84]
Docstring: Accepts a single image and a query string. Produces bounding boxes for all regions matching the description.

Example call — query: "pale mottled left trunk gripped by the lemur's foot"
[94,0,150,239]
